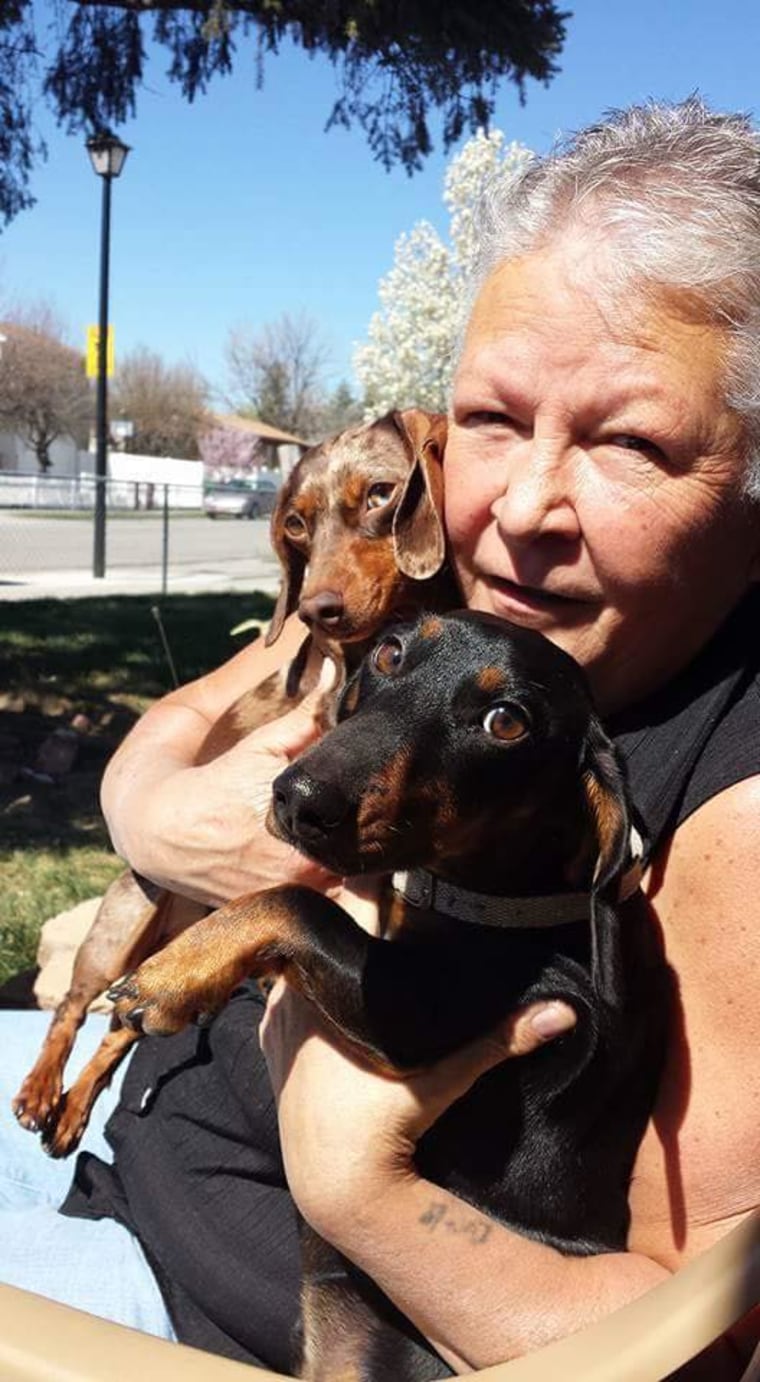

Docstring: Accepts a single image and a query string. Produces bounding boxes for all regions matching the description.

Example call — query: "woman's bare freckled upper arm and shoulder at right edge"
[630,777,760,1269]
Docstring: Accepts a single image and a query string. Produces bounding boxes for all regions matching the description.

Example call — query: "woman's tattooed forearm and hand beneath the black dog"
[261,987,667,1372]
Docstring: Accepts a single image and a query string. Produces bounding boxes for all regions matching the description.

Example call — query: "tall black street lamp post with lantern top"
[87,131,130,576]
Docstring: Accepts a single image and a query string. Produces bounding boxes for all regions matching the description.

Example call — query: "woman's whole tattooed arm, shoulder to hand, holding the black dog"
[264,779,760,1382]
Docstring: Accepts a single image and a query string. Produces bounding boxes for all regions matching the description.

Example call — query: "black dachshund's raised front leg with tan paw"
[109,886,453,1075]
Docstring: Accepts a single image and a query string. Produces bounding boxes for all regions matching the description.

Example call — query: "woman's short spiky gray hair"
[468,95,760,500]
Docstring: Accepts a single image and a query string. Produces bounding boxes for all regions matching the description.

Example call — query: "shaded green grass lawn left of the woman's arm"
[0,593,272,985]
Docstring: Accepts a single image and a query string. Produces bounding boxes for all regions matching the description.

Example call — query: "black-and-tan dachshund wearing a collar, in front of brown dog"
[112,612,669,1382]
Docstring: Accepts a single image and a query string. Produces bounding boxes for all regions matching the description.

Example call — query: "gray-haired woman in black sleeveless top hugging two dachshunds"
[0,101,760,1379]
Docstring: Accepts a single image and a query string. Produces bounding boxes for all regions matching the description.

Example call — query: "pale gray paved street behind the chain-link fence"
[0,510,278,600]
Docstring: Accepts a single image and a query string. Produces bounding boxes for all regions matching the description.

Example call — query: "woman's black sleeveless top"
[62,591,760,1372]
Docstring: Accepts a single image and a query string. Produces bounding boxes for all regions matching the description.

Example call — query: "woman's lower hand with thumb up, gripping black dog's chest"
[261,981,575,1256]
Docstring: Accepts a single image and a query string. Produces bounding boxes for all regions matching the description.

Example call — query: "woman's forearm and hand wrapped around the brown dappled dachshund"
[101,619,338,905]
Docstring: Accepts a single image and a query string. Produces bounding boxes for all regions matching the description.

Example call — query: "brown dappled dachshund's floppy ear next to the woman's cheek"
[391,408,446,580]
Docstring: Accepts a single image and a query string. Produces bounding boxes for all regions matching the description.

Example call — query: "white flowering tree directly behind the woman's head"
[354,130,532,419]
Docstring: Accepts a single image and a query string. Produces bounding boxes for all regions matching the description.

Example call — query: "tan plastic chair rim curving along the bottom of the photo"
[0,1213,760,1382]
